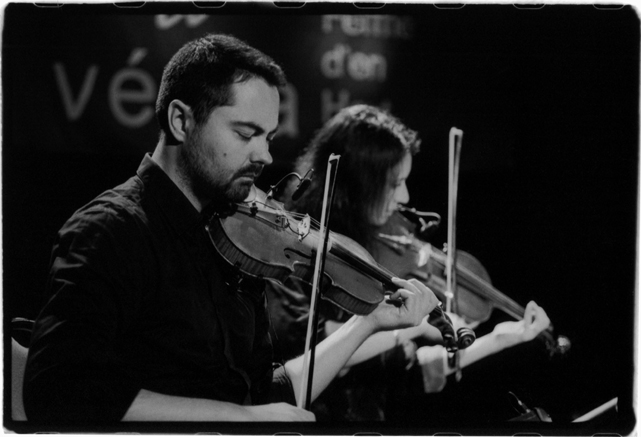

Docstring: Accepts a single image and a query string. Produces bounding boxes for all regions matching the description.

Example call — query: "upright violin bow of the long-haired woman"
[445,127,463,380]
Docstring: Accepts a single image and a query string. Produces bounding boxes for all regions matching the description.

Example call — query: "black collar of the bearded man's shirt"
[136,154,204,235]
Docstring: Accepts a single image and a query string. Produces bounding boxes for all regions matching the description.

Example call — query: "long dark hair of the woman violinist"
[286,105,421,249]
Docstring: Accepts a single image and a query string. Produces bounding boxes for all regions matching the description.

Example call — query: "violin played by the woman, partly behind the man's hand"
[373,209,570,355]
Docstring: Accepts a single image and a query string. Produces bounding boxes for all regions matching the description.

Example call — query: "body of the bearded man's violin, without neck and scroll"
[208,197,386,315]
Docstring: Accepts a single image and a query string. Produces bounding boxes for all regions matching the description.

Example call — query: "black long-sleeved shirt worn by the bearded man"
[24,156,294,421]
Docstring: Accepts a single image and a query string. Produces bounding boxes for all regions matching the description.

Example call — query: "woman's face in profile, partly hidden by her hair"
[370,153,412,226]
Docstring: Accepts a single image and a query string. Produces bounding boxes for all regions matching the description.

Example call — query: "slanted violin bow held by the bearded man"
[298,153,340,410]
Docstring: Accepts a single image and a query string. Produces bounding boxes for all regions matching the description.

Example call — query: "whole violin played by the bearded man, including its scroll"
[206,188,468,351]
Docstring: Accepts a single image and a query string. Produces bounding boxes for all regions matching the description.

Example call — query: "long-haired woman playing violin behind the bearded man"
[268,105,550,420]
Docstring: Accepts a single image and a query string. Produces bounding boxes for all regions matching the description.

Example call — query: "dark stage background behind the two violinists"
[2,3,639,435]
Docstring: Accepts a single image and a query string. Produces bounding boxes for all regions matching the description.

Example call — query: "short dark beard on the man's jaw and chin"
[178,136,263,203]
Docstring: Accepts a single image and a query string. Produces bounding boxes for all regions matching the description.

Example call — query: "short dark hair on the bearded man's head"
[156,34,286,137]
